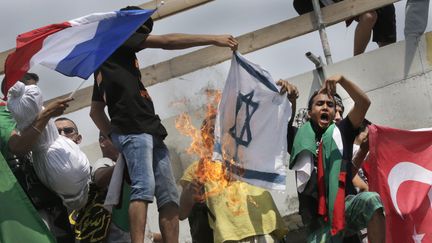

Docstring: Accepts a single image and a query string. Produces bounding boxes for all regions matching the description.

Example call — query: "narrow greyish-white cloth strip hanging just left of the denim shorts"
[104,155,125,212]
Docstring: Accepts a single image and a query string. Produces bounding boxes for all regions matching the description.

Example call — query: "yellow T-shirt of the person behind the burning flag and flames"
[180,162,288,242]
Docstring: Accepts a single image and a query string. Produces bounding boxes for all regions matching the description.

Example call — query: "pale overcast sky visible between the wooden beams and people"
[0,0,432,145]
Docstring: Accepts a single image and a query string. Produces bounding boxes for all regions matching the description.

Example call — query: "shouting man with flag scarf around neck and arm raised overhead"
[288,75,385,243]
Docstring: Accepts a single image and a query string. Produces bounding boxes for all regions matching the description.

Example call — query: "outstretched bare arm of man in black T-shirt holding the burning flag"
[140,34,238,51]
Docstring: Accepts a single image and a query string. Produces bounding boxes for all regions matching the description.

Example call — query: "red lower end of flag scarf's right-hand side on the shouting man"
[331,171,346,235]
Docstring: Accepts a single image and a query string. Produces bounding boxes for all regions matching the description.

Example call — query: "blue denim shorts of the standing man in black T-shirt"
[111,133,179,208]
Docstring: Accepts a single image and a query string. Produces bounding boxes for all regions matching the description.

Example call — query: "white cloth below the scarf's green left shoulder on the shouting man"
[292,151,314,193]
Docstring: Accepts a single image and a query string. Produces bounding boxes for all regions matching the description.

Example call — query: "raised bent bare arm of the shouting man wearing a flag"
[320,75,371,128]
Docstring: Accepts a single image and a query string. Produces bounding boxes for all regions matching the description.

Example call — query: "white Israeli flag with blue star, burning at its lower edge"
[213,52,291,190]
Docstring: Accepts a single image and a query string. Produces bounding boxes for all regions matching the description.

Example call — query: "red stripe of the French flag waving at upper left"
[1,22,71,98]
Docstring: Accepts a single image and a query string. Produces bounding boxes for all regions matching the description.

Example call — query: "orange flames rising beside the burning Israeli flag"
[175,90,258,216]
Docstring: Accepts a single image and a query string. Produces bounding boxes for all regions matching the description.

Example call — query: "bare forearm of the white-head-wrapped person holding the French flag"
[8,98,72,155]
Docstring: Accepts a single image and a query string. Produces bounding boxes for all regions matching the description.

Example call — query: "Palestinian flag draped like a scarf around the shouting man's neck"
[290,122,346,235]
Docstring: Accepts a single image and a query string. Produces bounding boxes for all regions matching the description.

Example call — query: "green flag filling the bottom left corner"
[0,154,55,243]
